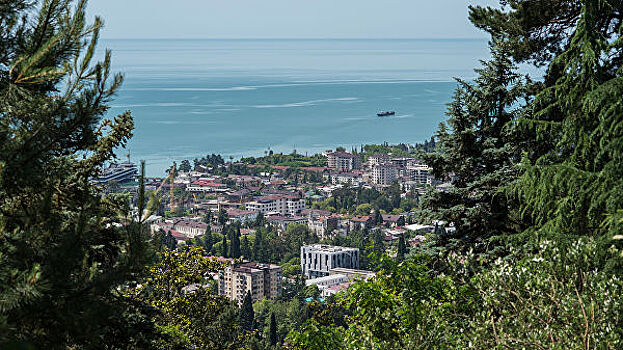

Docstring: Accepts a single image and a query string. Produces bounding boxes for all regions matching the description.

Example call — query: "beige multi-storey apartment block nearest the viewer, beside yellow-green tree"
[219,262,281,305]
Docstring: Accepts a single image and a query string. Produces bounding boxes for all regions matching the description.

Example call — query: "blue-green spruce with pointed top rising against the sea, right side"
[422,41,529,253]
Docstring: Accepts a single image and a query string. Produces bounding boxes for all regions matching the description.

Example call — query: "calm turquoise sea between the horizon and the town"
[100,40,488,176]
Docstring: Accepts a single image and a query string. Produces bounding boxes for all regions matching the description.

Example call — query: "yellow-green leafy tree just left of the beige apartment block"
[126,246,235,349]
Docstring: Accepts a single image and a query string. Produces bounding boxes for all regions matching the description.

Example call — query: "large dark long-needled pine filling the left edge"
[0,0,153,349]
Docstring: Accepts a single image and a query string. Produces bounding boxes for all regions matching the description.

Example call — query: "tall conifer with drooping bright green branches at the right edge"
[514,0,623,245]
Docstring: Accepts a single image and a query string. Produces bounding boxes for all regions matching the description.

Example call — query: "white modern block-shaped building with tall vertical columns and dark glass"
[301,244,359,278]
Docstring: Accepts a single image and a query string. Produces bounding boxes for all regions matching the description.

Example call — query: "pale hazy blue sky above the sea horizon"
[89,0,498,39]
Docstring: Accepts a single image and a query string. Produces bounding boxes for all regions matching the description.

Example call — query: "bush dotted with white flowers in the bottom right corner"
[462,238,623,349]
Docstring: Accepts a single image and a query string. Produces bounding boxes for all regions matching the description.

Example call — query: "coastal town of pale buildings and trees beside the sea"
[94,141,453,304]
